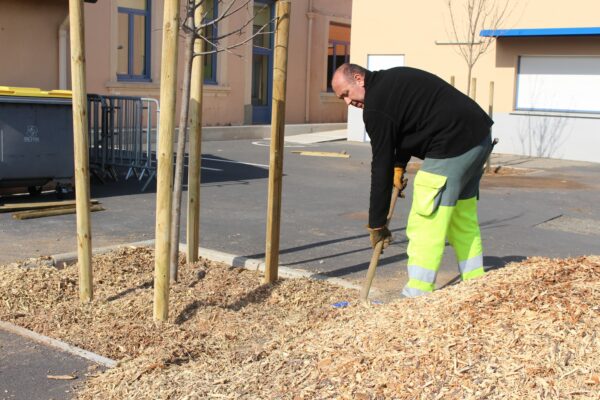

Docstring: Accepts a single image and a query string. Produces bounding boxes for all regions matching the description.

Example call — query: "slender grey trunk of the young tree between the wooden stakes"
[170,27,194,282]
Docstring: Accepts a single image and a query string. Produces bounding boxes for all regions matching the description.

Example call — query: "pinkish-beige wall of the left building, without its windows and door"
[0,0,352,125]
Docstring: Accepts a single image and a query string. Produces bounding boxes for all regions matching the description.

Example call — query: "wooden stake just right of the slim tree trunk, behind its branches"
[186,0,204,263]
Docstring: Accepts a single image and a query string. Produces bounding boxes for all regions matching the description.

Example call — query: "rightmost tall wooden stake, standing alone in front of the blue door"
[264,0,291,283]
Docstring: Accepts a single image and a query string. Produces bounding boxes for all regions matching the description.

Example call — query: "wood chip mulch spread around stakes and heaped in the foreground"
[0,248,600,400]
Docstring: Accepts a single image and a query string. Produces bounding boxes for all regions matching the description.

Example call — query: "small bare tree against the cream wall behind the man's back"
[447,0,514,95]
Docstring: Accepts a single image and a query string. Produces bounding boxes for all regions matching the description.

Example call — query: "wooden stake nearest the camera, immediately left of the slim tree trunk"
[154,0,179,321]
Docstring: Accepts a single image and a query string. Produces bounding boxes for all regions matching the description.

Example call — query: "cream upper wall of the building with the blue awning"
[351,0,600,112]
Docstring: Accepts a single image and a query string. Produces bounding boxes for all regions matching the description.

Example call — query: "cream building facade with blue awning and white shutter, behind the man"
[348,0,600,162]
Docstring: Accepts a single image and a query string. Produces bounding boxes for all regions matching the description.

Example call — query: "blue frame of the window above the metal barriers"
[117,0,152,82]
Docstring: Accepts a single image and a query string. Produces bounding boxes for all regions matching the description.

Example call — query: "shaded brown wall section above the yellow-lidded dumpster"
[0,0,68,89]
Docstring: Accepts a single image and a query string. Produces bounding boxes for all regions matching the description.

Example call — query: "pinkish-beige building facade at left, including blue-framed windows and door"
[0,0,352,126]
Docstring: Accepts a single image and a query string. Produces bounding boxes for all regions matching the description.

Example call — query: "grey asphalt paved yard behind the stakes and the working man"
[0,140,600,298]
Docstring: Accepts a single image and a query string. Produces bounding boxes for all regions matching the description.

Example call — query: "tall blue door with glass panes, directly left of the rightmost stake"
[252,0,274,124]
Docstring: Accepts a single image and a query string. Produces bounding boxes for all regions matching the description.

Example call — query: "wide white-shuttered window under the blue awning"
[516,56,600,113]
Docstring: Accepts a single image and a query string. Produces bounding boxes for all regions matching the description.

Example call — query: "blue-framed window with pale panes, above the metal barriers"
[117,0,151,81]
